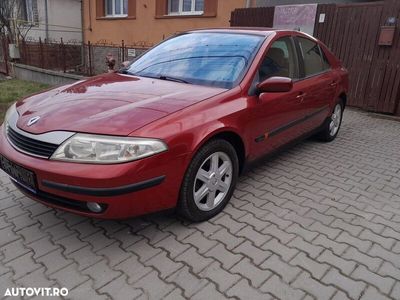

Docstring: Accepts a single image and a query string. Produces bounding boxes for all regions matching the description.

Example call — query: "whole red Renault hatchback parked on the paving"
[0,28,348,221]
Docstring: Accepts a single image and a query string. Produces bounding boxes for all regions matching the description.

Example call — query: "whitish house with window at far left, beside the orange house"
[21,0,82,42]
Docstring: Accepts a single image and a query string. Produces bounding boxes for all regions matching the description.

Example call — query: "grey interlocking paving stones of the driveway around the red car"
[0,110,400,300]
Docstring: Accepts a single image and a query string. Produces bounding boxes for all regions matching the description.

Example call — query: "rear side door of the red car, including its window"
[295,36,337,130]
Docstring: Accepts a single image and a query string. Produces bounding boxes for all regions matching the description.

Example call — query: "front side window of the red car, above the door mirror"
[258,37,298,82]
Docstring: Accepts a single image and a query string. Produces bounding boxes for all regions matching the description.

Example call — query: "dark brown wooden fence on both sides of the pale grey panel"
[231,0,400,116]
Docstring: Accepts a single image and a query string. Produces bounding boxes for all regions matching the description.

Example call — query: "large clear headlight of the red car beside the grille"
[50,133,168,164]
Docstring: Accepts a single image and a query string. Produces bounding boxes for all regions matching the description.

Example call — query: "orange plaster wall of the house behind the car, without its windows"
[83,0,246,46]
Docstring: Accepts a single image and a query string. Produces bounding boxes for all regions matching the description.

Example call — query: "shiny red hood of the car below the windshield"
[17,73,226,135]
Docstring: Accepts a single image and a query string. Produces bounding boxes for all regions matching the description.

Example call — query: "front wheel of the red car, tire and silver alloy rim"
[177,139,239,222]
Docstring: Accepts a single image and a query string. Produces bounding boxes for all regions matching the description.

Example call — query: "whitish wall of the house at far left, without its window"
[26,0,82,42]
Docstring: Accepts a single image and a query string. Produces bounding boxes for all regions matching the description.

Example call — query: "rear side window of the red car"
[297,37,330,77]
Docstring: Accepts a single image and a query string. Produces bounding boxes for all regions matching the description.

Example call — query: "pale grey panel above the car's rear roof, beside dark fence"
[274,4,318,35]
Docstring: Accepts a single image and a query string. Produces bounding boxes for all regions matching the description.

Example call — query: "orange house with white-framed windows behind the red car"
[83,0,248,46]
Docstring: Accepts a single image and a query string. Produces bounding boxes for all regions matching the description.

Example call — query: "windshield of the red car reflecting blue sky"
[125,32,263,89]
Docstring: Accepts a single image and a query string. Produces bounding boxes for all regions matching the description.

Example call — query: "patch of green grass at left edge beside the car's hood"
[0,79,50,124]
